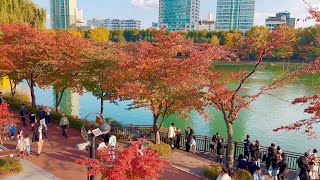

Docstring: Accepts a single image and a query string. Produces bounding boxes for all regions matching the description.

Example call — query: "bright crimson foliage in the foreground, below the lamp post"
[76,139,171,180]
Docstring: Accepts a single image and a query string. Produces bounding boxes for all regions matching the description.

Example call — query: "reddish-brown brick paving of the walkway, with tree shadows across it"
[4,112,200,180]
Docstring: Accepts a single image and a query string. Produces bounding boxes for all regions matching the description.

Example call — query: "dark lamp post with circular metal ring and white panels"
[77,112,111,180]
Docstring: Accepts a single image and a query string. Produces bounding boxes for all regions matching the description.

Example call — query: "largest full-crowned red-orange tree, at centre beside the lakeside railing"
[117,30,224,143]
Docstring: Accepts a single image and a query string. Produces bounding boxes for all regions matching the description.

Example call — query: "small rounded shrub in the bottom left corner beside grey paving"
[0,157,23,177]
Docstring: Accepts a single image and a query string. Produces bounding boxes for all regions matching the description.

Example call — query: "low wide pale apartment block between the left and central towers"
[87,19,141,30]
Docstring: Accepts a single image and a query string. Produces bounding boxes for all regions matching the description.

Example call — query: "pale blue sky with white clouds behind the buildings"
[34,0,320,28]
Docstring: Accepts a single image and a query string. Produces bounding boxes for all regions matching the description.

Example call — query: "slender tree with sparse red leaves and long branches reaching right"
[206,26,294,168]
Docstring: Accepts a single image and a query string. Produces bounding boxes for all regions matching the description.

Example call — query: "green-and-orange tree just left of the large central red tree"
[83,44,118,114]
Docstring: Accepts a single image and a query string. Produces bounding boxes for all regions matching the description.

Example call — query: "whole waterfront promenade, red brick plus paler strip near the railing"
[4,112,295,180]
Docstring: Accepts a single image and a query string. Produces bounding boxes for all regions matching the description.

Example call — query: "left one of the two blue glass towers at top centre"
[159,0,200,31]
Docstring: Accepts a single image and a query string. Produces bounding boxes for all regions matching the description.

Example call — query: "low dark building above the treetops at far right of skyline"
[266,11,296,31]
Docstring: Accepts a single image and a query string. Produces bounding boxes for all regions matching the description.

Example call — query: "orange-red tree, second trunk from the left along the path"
[47,31,91,112]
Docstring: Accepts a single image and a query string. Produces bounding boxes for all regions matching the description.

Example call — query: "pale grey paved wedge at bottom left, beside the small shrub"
[4,159,59,180]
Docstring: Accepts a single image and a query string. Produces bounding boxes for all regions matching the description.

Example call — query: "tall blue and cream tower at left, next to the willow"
[50,0,78,29]
